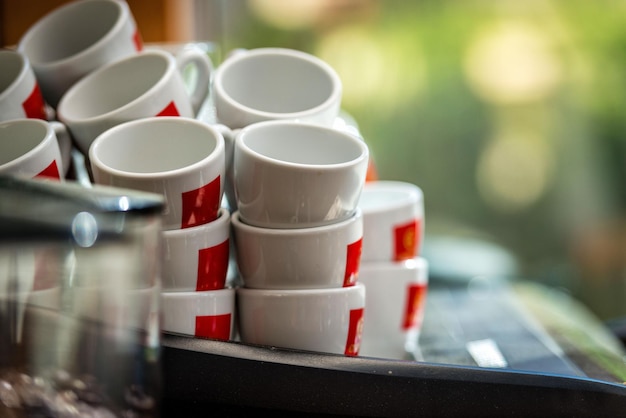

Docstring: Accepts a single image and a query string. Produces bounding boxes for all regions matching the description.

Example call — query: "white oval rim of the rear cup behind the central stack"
[213,47,343,119]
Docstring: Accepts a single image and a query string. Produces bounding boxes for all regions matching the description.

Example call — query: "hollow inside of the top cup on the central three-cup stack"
[240,122,366,165]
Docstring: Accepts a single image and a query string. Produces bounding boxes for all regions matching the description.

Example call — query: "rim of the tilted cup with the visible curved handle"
[57,49,176,125]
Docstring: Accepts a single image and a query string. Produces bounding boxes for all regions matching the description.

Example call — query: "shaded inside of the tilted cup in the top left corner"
[20,0,122,64]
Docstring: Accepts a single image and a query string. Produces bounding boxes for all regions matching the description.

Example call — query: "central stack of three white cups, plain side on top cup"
[231,121,369,356]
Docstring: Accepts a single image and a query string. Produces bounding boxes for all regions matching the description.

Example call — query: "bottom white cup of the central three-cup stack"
[237,283,365,356]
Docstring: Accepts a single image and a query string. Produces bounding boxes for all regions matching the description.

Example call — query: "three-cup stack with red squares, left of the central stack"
[89,116,235,340]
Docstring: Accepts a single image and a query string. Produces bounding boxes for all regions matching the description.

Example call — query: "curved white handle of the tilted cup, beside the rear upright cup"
[176,46,213,115]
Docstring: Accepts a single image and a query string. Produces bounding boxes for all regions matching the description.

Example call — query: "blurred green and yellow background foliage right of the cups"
[211,0,626,319]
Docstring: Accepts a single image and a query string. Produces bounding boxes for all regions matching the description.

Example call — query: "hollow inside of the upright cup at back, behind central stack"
[221,52,337,113]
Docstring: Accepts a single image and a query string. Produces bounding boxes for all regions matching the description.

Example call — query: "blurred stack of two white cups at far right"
[358,180,428,358]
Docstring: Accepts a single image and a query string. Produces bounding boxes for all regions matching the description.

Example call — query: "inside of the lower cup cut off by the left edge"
[0,119,48,165]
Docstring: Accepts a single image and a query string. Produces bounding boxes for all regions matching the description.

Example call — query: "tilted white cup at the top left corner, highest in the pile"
[18,0,142,108]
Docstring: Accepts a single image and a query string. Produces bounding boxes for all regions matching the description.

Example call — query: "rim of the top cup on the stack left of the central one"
[89,116,225,180]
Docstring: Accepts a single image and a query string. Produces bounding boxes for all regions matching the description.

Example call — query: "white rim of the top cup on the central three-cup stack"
[235,119,369,172]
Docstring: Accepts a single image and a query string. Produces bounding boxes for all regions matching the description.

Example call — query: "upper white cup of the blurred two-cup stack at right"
[359,180,424,262]
